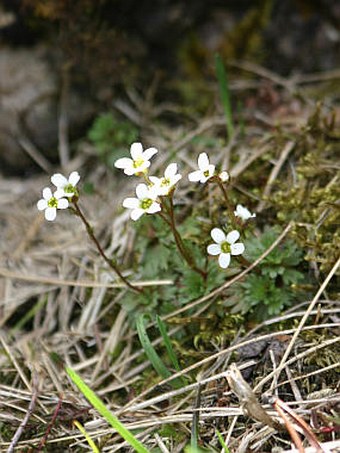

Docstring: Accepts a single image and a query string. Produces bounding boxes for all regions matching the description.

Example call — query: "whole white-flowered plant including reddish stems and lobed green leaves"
[37,142,303,319]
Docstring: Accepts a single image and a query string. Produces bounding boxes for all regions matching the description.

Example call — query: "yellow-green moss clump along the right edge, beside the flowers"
[270,108,340,272]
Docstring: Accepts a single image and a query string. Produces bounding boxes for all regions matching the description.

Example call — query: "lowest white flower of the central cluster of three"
[123,183,161,220]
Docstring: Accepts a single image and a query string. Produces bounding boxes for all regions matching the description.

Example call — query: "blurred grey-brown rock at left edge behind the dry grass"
[0,46,94,174]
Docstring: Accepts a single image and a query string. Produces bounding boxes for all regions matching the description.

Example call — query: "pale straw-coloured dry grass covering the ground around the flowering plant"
[0,68,340,453]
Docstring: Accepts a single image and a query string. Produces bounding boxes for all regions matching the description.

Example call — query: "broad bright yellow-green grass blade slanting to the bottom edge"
[65,367,150,453]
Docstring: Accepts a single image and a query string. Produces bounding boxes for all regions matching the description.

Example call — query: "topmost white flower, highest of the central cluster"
[114,143,158,176]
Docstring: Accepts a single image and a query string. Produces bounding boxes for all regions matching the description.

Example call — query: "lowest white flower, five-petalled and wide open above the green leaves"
[207,228,245,269]
